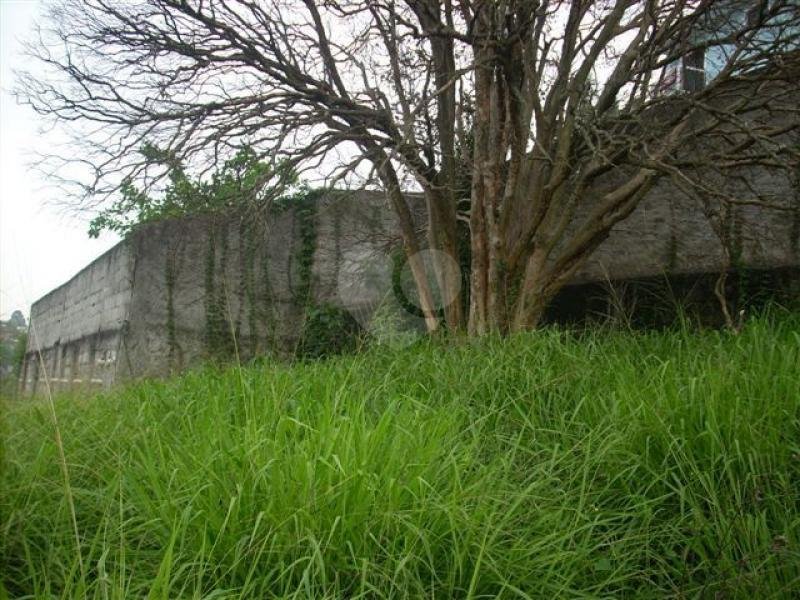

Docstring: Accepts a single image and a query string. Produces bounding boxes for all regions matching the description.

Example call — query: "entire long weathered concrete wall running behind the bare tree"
[18,176,800,393]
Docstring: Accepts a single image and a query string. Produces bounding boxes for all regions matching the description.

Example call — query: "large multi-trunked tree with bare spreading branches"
[20,0,800,334]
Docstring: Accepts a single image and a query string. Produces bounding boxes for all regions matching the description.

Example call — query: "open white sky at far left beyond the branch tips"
[0,0,117,319]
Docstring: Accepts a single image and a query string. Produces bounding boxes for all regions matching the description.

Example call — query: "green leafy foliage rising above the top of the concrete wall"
[89,145,297,237]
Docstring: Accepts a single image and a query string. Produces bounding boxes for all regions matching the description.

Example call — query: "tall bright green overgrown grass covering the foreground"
[0,315,800,599]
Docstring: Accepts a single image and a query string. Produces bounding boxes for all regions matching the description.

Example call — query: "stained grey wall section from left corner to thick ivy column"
[125,204,297,377]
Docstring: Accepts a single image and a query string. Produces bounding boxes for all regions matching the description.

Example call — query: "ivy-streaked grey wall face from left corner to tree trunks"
[122,192,416,376]
